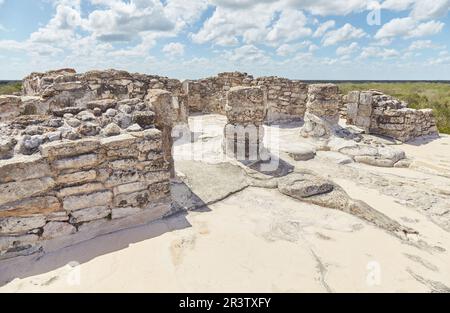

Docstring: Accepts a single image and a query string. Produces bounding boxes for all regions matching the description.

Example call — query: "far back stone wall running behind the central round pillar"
[183,72,308,122]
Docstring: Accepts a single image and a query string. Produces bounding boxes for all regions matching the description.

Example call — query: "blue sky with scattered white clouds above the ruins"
[0,0,450,80]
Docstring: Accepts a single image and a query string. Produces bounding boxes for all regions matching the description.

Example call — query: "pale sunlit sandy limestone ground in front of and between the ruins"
[0,115,450,292]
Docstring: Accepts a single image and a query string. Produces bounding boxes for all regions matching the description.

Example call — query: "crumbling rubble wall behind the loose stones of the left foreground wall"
[19,69,188,123]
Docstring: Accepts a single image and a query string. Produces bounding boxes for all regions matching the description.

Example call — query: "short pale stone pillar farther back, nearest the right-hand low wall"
[300,84,339,138]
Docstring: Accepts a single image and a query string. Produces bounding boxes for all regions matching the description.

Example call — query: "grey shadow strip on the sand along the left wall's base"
[0,183,211,287]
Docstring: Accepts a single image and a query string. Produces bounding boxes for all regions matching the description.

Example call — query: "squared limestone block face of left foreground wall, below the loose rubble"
[0,133,171,259]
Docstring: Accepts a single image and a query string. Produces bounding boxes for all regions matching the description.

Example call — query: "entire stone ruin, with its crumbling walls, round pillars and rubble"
[0,69,436,259]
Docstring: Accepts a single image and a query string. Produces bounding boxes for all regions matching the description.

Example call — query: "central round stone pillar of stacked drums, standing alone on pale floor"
[223,86,269,162]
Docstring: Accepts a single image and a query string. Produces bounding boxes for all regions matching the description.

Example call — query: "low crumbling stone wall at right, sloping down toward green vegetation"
[345,90,438,142]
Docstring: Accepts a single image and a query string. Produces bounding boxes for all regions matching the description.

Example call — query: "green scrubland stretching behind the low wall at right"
[338,82,450,134]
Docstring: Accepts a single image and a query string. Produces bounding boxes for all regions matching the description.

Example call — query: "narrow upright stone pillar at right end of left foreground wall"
[145,89,176,178]
